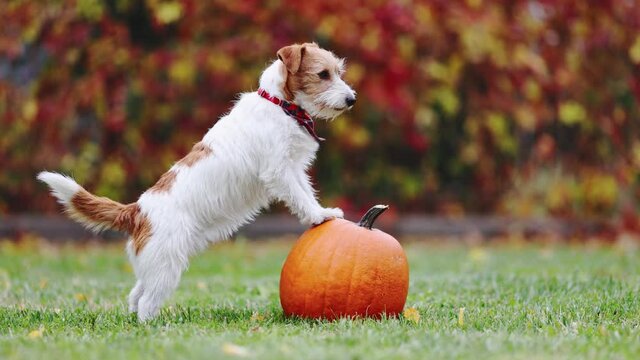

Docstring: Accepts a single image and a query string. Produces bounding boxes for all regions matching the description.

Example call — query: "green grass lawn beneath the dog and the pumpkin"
[0,241,640,359]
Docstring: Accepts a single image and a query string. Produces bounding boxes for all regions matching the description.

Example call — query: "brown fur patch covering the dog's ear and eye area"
[278,43,342,101]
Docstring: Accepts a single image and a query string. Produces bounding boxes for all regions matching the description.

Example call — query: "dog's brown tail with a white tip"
[38,171,141,234]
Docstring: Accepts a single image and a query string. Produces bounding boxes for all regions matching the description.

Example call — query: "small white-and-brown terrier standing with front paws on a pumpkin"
[38,43,356,321]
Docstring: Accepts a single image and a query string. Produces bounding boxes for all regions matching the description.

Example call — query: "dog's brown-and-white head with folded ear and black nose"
[278,43,356,120]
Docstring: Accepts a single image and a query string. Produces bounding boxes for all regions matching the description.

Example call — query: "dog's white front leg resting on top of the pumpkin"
[268,168,344,225]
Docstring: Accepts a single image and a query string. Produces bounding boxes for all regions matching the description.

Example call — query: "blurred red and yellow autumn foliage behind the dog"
[0,0,640,227]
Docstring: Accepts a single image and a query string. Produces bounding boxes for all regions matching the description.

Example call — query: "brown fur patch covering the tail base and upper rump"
[67,189,151,255]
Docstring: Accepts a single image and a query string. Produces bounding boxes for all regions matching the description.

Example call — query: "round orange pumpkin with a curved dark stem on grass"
[280,205,409,319]
